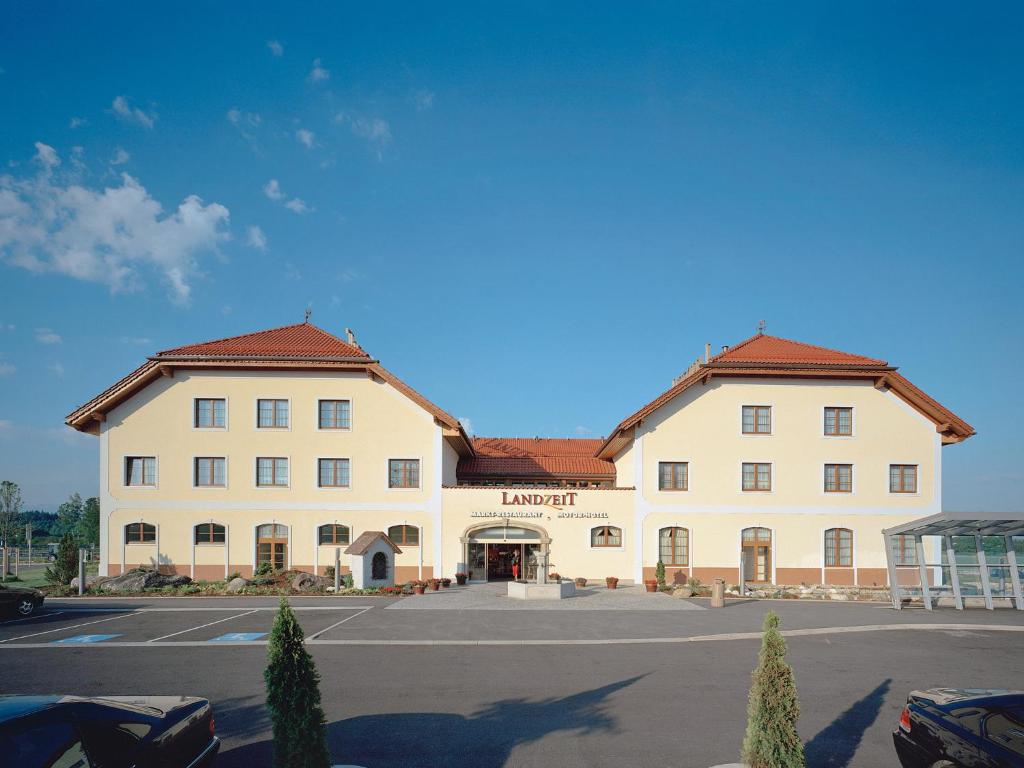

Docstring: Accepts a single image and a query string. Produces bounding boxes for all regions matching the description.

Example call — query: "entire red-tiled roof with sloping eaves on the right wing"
[595,334,975,459]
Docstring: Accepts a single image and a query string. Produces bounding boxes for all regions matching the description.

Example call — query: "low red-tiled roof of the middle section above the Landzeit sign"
[457,437,615,479]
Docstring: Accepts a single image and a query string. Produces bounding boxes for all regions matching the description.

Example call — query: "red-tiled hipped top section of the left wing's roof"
[156,323,370,360]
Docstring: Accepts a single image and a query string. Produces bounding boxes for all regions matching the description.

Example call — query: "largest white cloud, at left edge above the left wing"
[0,144,229,303]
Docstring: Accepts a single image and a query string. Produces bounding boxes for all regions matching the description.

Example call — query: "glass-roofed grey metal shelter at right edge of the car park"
[882,512,1024,610]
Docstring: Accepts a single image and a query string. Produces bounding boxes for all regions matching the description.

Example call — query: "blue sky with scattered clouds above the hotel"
[0,3,1024,509]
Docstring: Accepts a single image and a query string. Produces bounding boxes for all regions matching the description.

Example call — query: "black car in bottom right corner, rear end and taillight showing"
[893,688,1024,768]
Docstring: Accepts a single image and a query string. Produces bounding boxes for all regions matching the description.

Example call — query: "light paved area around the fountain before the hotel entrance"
[387,584,703,610]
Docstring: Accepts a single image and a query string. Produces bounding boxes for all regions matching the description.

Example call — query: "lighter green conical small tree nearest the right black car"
[742,611,805,768]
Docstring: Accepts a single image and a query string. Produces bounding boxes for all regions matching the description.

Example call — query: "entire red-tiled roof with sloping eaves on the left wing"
[65,323,472,454]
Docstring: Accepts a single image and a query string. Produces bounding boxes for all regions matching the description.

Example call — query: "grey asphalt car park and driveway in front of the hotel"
[0,598,1024,768]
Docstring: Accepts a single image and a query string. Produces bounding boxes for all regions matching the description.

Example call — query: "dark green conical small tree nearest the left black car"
[263,598,331,768]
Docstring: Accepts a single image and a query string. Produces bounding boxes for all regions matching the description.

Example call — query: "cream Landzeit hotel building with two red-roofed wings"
[67,324,974,586]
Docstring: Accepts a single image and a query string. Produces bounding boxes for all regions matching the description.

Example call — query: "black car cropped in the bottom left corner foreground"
[0,696,220,768]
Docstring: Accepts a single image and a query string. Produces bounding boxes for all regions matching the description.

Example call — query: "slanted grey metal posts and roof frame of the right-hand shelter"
[882,512,1024,610]
